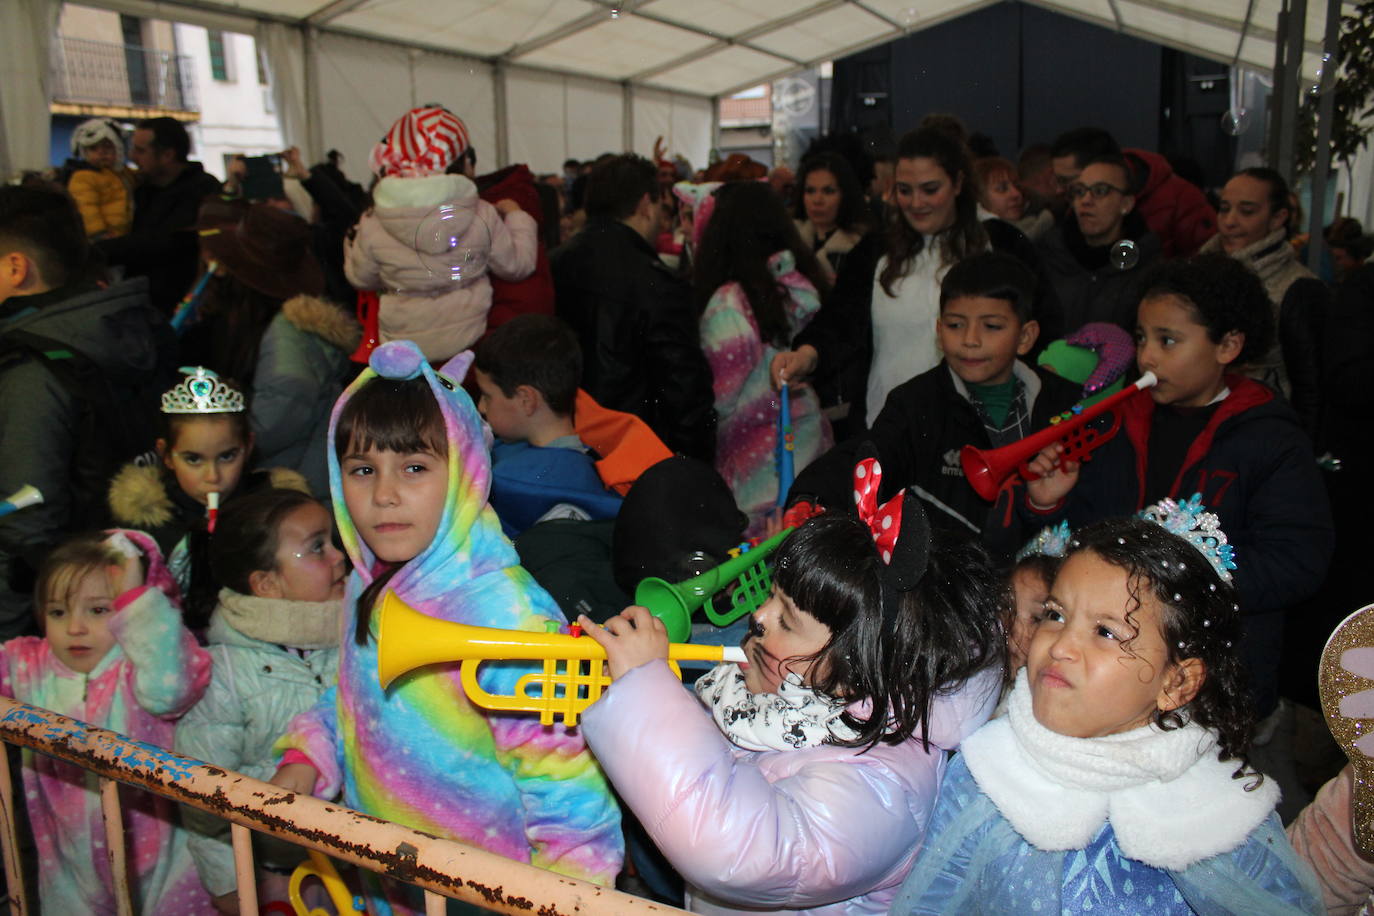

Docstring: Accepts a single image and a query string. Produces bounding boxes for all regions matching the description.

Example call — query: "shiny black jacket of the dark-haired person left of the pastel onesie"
[552,218,716,461]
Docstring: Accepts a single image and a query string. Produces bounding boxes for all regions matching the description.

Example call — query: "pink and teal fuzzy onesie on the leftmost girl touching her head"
[0,529,214,916]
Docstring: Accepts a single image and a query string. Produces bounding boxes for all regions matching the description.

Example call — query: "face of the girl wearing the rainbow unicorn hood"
[339,444,448,563]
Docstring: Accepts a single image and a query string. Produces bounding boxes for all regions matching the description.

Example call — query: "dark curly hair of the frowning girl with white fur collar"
[1065,518,1264,790]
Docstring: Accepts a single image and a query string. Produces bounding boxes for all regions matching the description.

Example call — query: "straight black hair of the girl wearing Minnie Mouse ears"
[774,513,1010,750]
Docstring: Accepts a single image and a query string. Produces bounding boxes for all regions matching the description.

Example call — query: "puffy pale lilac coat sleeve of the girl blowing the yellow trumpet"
[583,661,944,909]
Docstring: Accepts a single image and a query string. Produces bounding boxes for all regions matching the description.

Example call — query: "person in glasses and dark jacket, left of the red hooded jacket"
[1036,154,1160,334]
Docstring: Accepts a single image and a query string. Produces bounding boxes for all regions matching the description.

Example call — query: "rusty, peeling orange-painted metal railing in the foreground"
[0,696,684,916]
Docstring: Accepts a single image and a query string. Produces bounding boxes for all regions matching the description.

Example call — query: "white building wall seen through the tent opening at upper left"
[176,22,284,179]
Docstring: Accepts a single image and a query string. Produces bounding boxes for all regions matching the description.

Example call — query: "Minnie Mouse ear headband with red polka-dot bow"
[855,445,930,630]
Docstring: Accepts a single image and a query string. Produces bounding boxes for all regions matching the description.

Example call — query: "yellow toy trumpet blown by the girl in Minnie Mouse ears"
[376,592,746,725]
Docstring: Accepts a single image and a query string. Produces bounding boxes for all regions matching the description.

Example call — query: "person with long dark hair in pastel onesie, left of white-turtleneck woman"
[694,181,830,534]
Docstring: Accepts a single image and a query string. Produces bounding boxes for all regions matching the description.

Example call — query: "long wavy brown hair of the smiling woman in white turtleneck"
[878,128,988,295]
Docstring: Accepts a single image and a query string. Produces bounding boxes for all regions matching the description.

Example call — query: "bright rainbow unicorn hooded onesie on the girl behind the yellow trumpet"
[278,341,624,913]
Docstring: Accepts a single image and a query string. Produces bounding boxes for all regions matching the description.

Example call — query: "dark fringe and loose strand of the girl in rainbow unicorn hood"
[334,375,448,645]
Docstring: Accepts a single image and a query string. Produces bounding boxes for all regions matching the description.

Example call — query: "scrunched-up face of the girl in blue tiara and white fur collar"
[1026,551,1201,737]
